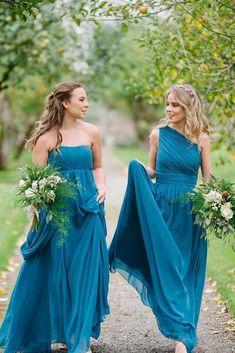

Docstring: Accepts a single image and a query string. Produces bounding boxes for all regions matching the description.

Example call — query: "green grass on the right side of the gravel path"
[115,146,235,316]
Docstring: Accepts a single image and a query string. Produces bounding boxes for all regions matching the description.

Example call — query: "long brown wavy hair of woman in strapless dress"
[25,81,82,150]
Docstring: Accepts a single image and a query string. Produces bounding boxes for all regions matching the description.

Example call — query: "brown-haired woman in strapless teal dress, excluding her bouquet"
[0,82,109,353]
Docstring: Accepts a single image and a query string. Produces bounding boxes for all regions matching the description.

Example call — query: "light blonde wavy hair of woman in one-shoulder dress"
[158,84,209,143]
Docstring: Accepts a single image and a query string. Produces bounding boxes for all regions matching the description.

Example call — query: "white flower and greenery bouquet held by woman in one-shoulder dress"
[187,176,235,249]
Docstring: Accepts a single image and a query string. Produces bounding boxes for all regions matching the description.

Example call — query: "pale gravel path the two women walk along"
[0,150,235,353]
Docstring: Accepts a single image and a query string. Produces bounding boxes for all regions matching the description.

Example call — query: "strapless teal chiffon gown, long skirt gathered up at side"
[0,146,109,353]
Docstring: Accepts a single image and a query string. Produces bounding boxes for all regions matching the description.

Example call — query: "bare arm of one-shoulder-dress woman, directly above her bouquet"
[200,134,211,183]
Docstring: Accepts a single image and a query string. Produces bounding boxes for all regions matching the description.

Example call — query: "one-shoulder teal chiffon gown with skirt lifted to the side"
[109,126,207,353]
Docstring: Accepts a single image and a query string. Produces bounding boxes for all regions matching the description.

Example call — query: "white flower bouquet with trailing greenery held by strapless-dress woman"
[16,165,77,246]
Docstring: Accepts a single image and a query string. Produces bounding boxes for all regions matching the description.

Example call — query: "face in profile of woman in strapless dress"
[63,87,89,119]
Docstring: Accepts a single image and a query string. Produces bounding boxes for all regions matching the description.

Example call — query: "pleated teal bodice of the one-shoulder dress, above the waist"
[156,126,201,185]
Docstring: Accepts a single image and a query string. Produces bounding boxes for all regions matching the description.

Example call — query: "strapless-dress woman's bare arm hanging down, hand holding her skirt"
[91,127,106,203]
